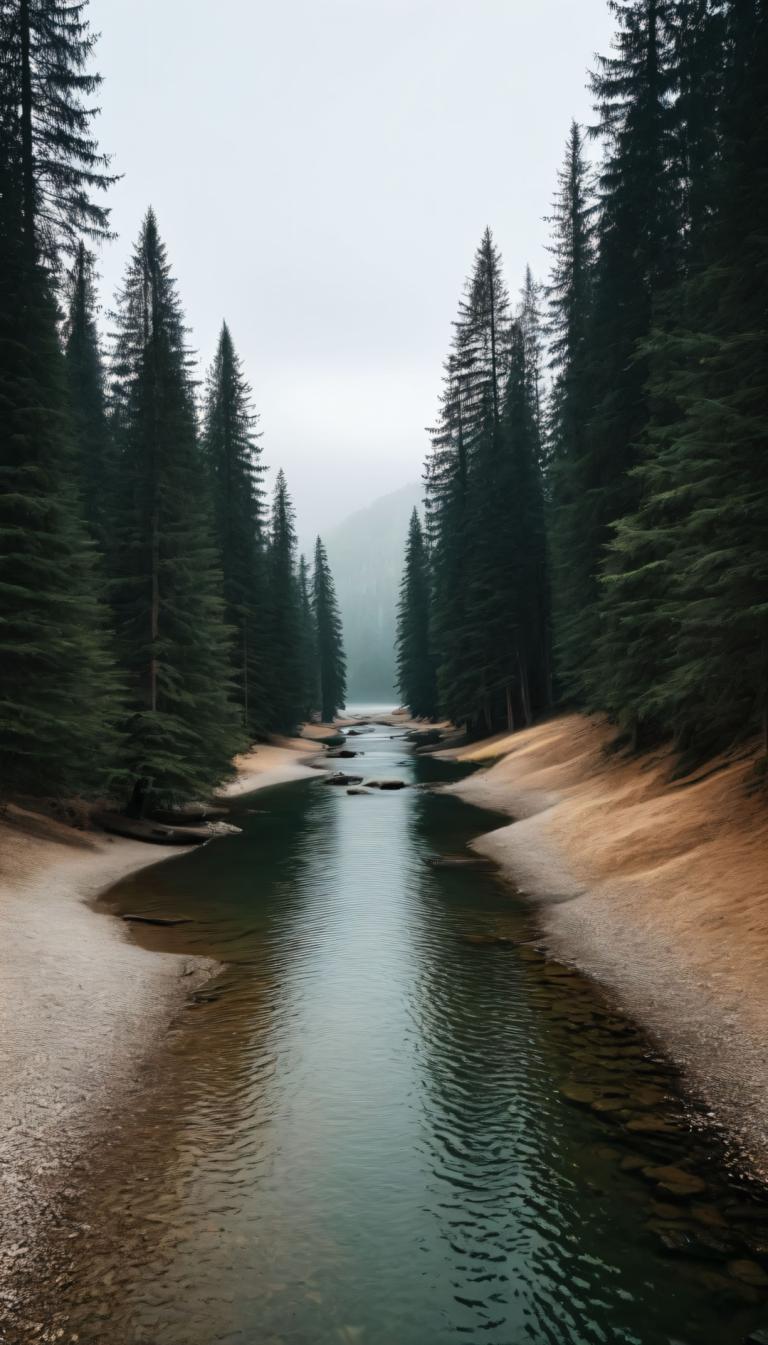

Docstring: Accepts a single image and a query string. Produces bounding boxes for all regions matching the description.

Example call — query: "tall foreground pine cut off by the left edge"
[0,4,116,794]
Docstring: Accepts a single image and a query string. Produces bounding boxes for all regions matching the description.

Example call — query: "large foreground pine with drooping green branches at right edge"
[604,0,768,756]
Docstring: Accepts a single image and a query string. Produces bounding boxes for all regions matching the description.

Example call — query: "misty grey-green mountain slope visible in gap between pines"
[325,482,421,702]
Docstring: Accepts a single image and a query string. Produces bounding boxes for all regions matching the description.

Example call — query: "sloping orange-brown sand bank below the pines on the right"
[445,716,768,1177]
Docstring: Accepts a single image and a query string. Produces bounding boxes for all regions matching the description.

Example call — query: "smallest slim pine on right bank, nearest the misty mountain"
[397,508,437,720]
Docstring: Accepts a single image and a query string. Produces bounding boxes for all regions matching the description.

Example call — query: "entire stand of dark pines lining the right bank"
[399,0,768,755]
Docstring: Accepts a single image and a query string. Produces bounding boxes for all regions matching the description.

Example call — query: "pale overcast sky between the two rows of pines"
[90,0,612,537]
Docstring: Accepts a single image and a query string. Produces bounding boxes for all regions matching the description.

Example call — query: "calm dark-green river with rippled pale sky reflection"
[31,726,768,1345]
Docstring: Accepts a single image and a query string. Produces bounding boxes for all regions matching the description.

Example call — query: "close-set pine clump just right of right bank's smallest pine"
[426,230,550,732]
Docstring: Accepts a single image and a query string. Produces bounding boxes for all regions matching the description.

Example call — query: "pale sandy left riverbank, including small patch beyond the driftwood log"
[0,740,321,1296]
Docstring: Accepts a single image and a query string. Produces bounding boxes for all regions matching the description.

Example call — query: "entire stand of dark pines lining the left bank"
[0,0,344,799]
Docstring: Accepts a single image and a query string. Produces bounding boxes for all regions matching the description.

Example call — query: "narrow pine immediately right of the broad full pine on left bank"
[203,323,269,737]
